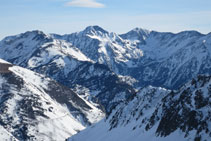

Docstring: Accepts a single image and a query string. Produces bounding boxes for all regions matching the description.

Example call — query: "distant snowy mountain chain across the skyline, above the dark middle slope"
[0,26,211,89]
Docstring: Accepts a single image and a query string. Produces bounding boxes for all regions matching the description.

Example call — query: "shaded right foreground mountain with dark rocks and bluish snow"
[69,76,211,141]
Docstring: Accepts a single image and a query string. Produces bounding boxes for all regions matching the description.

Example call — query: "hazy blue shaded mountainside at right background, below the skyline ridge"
[126,31,211,89]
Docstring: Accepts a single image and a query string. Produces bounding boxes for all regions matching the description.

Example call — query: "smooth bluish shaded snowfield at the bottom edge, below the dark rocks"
[68,120,187,141]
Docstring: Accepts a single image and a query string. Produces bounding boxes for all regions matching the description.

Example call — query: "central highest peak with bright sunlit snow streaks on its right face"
[52,26,143,74]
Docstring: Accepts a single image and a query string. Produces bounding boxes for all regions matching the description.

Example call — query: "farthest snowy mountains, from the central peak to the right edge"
[52,26,211,89]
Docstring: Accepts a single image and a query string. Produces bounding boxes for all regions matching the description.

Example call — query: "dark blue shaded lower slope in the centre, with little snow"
[61,62,136,112]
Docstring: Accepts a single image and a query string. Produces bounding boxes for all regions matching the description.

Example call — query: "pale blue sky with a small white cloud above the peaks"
[0,0,211,39]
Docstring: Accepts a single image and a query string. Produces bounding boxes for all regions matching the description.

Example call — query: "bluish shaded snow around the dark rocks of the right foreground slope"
[69,79,211,141]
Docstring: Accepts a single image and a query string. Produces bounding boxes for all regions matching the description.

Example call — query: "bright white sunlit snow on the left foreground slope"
[0,66,105,141]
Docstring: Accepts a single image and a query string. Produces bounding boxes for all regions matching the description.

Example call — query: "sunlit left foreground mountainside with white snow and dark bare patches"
[0,60,104,141]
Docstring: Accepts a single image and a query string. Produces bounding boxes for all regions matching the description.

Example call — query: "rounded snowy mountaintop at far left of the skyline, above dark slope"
[0,31,90,71]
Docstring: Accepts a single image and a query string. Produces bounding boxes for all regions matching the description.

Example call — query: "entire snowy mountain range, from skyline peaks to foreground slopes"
[0,26,211,141]
